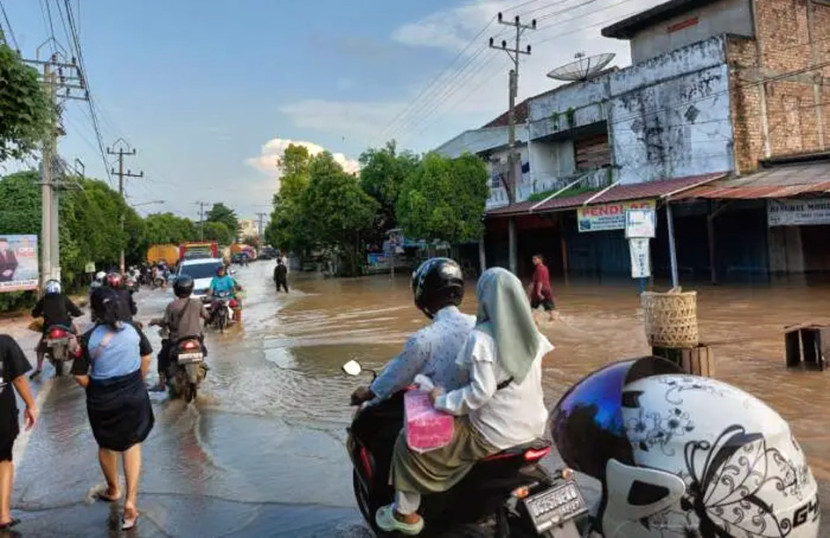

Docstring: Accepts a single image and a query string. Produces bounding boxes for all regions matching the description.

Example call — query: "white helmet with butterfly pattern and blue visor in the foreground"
[551,357,819,538]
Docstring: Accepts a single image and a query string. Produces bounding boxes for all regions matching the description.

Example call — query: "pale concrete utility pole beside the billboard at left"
[24,47,89,284]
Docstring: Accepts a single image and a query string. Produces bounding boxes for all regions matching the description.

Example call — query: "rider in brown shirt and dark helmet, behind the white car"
[150,275,210,392]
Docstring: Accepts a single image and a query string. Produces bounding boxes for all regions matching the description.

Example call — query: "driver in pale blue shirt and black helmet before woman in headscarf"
[352,258,476,405]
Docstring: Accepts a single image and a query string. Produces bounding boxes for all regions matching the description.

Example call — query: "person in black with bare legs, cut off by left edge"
[0,334,37,524]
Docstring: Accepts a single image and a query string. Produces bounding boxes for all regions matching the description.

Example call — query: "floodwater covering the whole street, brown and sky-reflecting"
[0,262,830,537]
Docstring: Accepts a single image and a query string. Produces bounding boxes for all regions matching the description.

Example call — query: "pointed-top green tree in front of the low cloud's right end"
[302,152,378,275]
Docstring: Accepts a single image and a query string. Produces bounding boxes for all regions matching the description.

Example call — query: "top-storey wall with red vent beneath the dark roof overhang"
[631,0,766,63]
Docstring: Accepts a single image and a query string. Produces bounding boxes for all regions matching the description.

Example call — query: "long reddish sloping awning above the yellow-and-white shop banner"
[486,172,728,218]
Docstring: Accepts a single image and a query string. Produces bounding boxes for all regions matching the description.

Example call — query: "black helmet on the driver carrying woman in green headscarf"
[412,258,464,318]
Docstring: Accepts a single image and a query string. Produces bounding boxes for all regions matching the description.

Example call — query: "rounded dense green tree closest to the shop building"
[396,153,488,243]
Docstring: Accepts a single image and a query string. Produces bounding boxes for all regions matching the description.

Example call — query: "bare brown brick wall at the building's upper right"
[727,0,830,173]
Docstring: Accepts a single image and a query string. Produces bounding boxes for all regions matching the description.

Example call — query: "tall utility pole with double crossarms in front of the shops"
[490,13,536,273]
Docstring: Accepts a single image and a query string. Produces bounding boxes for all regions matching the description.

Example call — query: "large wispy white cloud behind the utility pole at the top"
[280,0,664,151]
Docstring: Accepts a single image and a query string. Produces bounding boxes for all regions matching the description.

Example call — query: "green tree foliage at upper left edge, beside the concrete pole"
[0,44,55,162]
